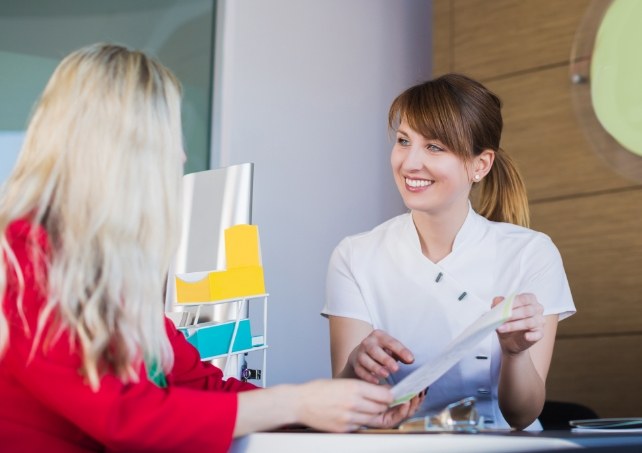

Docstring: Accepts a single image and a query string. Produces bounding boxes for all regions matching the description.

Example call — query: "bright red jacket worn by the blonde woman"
[0,221,256,453]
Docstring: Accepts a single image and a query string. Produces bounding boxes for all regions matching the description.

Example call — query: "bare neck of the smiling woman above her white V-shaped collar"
[411,204,468,263]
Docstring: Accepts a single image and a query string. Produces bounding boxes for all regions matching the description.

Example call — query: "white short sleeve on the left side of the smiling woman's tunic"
[321,238,372,325]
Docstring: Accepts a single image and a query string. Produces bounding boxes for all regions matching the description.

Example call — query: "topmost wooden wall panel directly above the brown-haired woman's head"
[452,0,588,80]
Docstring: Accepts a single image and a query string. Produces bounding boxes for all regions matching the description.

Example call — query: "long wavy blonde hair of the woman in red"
[0,44,184,389]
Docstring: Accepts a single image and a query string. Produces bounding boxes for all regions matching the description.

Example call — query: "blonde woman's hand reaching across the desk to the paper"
[294,379,396,432]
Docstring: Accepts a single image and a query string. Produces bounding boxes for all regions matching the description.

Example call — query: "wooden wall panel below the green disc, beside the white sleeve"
[531,188,642,336]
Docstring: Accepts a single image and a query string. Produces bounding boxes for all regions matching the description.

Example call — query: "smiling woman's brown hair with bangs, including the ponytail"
[388,74,529,227]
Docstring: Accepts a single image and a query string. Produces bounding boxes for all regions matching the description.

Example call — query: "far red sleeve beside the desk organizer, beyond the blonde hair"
[165,318,257,392]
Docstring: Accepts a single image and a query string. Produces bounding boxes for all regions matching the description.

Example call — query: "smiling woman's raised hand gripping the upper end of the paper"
[492,293,545,355]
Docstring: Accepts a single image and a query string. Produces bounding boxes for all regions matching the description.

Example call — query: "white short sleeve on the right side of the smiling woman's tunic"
[520,233,576,321]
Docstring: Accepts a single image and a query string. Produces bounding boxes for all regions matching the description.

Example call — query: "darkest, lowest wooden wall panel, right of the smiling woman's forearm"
[546,336,642,417]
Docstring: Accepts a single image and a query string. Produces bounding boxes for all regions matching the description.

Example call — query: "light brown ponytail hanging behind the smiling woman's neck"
[476,148,530,228]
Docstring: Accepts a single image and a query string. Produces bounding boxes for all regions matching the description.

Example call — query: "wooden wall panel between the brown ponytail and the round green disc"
[486,66,632,200]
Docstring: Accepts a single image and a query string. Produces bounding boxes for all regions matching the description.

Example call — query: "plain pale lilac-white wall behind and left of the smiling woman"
[212,0,431,385]
